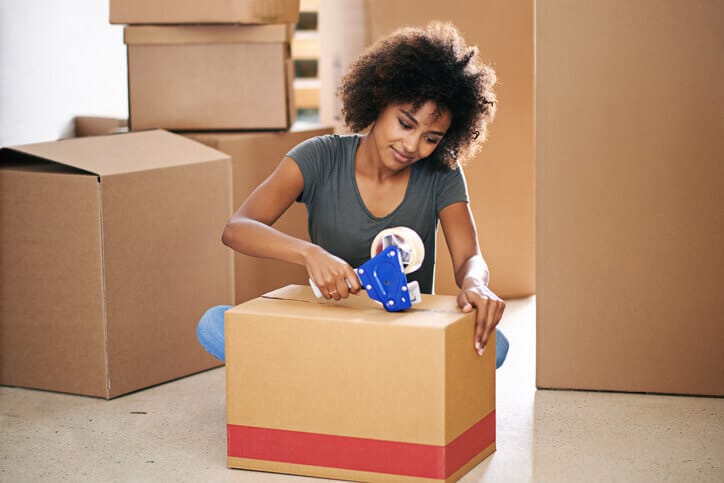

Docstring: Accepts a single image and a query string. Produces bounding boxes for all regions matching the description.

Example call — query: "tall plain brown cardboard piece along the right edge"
[537,0,724,396]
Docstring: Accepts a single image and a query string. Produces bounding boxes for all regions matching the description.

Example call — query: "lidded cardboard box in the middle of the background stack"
[124,24,296,130]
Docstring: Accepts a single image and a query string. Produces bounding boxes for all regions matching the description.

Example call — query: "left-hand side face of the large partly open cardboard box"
[0,163,107,397]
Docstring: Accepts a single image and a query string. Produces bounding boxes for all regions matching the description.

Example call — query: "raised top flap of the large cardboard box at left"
[10,130,228,176]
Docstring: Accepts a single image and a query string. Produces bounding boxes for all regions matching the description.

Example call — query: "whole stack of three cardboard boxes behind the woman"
[110,0,331,303]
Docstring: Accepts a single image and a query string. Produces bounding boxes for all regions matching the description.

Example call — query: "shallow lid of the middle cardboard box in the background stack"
[123,24,294,45]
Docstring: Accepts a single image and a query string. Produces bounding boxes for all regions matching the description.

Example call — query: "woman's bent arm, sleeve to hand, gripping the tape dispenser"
[221,156,361,300]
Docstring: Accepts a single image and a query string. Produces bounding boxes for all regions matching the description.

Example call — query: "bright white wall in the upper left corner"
[0,0,128,146]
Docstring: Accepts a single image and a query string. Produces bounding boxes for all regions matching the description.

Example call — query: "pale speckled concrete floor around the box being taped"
[0,297,724,482]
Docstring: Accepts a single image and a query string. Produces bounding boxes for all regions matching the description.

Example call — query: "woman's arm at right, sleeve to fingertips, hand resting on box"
[440,202,505,355]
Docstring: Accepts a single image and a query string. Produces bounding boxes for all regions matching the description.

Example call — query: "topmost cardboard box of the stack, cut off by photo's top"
[110,0,299,24]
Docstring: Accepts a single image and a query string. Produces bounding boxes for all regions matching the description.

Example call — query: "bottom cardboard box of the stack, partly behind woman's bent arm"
[186,122,332,304]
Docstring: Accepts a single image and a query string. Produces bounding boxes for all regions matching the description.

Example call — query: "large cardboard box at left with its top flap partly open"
[0,131,234,398]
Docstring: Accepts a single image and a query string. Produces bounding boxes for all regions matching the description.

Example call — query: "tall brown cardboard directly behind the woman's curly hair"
[342,0,535,298]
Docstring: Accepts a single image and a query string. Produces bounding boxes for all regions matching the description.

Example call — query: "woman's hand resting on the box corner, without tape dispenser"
[458,283,505,355]
